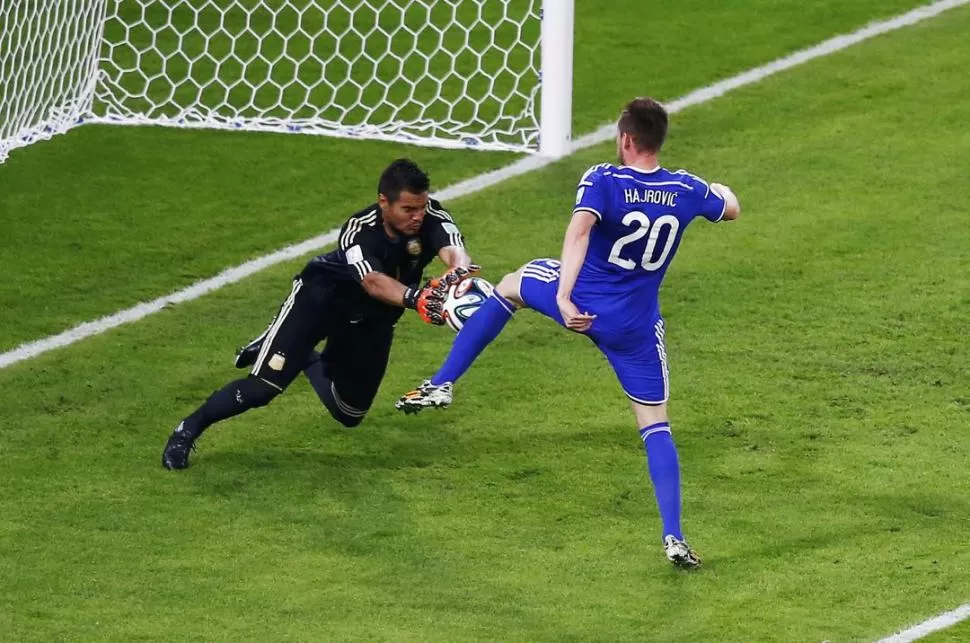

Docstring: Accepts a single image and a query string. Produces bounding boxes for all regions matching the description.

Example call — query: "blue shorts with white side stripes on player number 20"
[519,259,670,404]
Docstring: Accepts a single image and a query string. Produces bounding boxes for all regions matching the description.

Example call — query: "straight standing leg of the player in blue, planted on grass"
[596,320,701,568]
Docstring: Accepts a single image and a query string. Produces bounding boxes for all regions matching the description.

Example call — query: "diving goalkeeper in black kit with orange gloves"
[162,159,477,469]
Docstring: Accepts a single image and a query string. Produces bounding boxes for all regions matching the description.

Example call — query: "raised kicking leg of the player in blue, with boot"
[394,259,540,413]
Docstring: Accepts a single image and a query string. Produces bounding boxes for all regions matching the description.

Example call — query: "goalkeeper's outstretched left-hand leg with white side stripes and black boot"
[162,279,320,469]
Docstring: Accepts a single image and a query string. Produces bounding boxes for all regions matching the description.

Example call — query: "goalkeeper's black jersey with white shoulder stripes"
[299,199,464,324]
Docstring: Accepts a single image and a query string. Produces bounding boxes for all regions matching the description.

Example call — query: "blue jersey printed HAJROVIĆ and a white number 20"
[572,163,725,328]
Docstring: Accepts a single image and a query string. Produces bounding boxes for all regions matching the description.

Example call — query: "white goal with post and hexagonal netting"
[0,0,574,163]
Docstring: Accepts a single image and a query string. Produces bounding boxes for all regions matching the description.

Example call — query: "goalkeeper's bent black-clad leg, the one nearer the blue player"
[303,322,394,428]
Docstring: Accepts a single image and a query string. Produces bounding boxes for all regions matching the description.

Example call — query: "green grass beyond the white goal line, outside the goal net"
[0,0,932,350]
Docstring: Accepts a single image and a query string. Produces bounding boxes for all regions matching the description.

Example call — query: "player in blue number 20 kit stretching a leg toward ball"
[396,98,741,568]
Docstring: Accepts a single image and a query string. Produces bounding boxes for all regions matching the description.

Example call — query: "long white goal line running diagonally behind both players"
[0,0,970,369]
